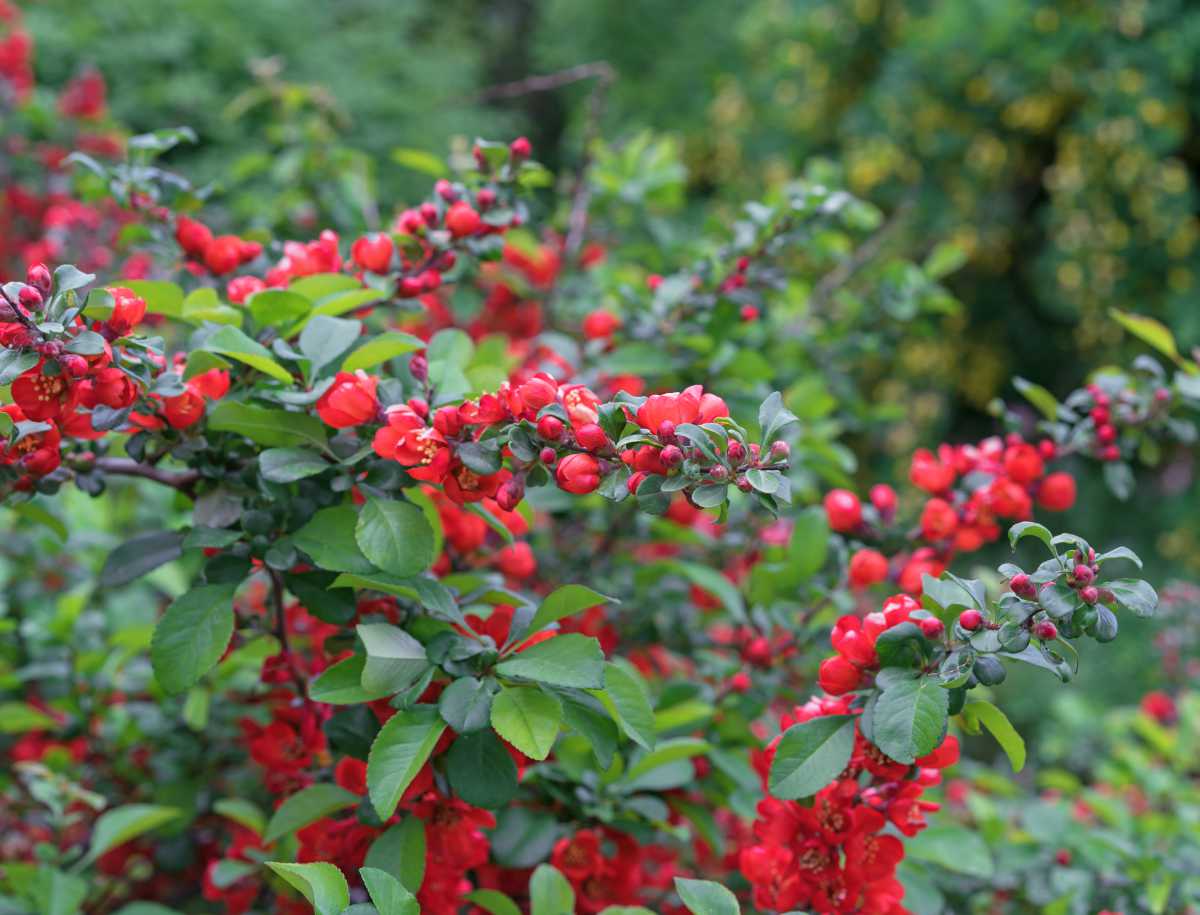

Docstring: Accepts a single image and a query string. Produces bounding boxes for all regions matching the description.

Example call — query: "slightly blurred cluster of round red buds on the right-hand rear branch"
[824,433,1075,594]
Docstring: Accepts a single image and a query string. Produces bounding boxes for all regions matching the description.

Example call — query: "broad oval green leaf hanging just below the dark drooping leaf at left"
[150,585,235,693]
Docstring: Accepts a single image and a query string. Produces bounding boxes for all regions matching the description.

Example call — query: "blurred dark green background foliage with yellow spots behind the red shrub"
[16,0,1200,754]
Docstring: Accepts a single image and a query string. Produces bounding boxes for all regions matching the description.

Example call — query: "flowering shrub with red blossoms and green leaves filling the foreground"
[0,30,1196,915]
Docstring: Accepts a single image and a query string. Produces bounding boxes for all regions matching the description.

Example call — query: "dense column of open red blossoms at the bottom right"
[739,594,959,915]
